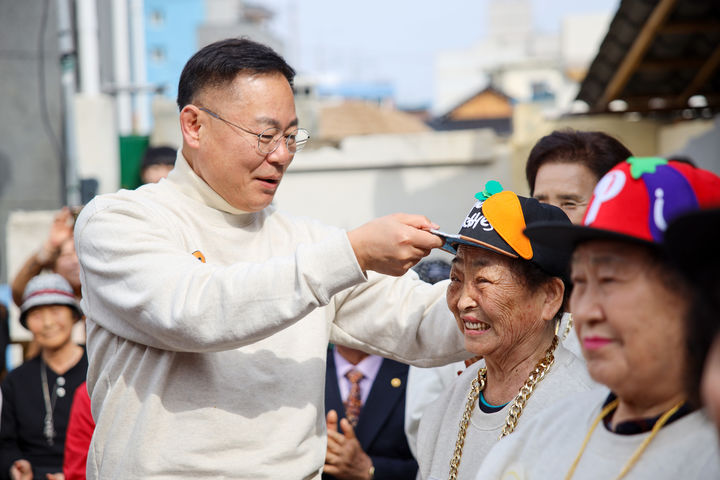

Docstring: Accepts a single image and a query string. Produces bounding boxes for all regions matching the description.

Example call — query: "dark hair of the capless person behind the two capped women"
[525,129,632,196]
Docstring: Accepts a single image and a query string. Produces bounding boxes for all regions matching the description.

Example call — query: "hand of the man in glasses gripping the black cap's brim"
[348,213,443,276]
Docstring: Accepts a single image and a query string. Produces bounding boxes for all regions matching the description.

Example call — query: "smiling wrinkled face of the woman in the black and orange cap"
[447,245,562,358]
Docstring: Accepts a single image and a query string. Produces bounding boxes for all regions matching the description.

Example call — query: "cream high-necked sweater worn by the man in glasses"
[75,154,466,480]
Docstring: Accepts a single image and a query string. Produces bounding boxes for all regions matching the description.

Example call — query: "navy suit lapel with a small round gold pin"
[352,359,407,451]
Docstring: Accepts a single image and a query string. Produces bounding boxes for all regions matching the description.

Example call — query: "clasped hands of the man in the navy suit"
[323,410,373,480]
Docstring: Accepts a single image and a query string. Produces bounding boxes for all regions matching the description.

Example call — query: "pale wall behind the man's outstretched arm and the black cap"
[275,130,510,232]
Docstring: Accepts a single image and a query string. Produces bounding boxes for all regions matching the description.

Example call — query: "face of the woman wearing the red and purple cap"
[570,241,688,401]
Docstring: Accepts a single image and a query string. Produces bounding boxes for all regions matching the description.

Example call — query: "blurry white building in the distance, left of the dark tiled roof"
[433,0,611,115]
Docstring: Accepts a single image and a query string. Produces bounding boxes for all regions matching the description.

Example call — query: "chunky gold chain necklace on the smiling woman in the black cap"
[449,335,558,480]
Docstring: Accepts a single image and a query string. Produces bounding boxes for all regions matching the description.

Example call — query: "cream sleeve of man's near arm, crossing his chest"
[75,197,365,352]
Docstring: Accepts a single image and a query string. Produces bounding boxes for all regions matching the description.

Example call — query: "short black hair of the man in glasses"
[177,38,295,110]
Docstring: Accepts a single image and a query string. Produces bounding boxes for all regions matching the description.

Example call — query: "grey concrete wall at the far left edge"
[0,1,63,283]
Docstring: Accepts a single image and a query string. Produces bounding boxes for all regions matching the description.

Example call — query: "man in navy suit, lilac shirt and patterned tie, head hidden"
[323,345,418,480]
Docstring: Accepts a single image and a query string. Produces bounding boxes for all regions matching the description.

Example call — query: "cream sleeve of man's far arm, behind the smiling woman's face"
[330,271,470,367]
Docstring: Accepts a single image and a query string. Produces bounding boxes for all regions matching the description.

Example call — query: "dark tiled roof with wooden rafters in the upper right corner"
[577,0,720,113]
